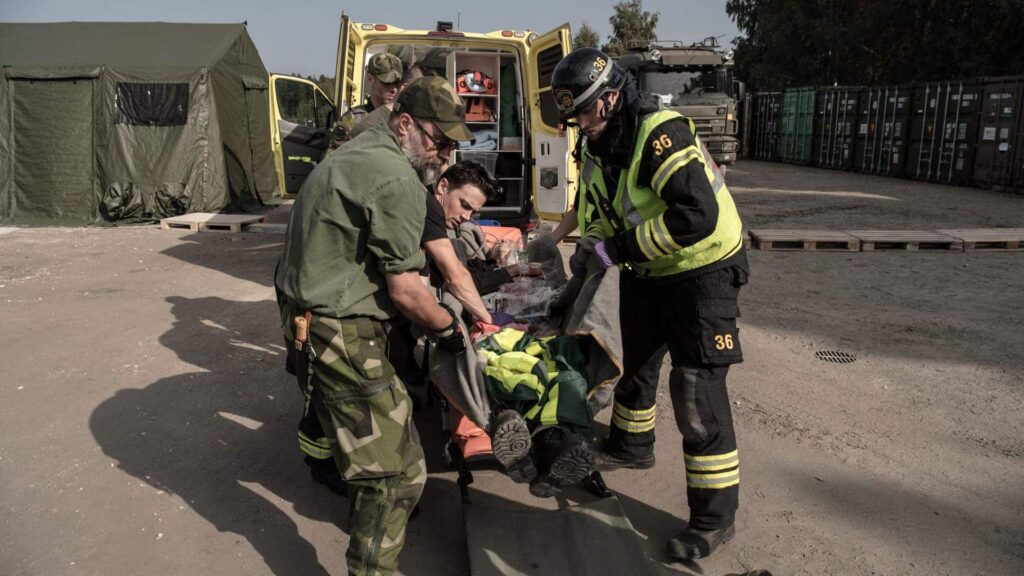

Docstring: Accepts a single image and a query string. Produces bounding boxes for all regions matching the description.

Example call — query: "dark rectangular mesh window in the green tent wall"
[117,82,188,126]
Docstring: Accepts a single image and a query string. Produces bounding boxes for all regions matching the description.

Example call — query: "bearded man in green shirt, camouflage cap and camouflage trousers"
[274,78,471,576]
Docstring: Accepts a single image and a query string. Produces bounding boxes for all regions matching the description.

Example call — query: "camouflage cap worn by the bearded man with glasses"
[394,76,475,141]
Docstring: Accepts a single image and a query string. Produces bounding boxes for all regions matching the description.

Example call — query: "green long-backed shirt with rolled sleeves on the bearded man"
[275,124,426,320]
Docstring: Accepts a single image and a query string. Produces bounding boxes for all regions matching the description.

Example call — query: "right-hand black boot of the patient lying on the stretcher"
[529,426,594,498]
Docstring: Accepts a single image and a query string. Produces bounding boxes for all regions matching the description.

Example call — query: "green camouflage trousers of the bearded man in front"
[309,316,427,576]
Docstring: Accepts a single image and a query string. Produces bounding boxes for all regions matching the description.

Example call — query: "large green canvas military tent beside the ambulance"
[0,23,282,225]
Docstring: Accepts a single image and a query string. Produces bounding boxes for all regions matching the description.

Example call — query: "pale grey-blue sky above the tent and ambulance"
[0,0,739,76]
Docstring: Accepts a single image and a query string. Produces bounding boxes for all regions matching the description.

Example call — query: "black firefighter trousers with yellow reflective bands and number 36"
[606,262,748,530]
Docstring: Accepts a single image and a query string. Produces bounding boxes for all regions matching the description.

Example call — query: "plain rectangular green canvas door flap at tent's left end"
[10,78,96,224]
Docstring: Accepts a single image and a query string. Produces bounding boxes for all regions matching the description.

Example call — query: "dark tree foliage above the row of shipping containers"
[726,0,1024,90]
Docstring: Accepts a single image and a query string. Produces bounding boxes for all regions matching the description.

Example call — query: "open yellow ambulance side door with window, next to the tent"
[269,74,337,196]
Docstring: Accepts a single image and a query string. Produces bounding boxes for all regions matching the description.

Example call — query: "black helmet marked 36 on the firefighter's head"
[551,48,626,121]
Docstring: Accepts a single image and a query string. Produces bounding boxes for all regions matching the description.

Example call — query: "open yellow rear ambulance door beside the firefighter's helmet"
[526,24,579,220]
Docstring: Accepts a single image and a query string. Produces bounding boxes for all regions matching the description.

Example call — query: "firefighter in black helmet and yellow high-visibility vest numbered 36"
[552,48,748,560]
